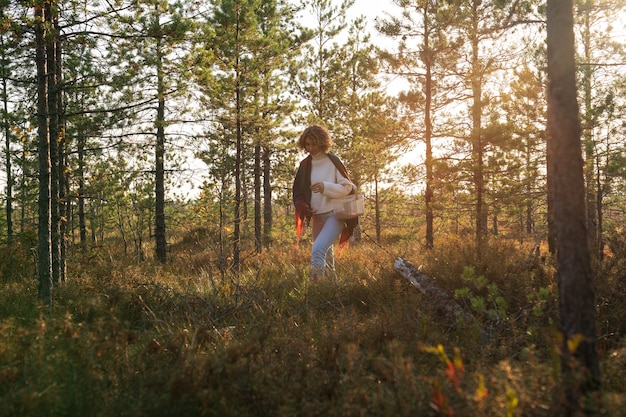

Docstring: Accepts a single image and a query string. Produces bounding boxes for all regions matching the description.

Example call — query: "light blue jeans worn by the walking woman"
[310,211,344,279]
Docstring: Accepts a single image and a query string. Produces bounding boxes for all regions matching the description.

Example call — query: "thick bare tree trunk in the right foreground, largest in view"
[547,0,600,410]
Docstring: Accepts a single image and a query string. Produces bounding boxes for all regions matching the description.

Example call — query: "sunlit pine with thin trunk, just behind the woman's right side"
[328,17,409,242]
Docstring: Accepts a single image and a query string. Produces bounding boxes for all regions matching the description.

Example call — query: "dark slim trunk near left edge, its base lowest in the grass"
[35,4,52,307]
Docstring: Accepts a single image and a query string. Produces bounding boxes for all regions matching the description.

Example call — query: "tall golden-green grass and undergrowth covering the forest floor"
[0,232,626,417]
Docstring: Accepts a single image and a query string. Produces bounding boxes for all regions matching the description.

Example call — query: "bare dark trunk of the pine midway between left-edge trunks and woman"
[154,34,167,264]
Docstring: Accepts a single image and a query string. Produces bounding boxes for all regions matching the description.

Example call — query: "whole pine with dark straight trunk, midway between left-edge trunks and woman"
[105,0,191,263]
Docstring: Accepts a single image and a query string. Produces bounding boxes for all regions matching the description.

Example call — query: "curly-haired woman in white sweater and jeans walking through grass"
[293,125,358,280]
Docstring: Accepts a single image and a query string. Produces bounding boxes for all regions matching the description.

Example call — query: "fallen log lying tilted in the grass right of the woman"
[393,258,489,341]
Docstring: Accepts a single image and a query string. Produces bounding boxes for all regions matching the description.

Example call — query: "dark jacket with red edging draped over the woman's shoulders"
[293,152,359,246]
